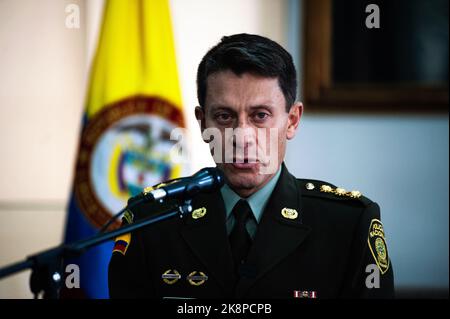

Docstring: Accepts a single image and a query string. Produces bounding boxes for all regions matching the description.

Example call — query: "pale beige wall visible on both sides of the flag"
[0,0,287,298]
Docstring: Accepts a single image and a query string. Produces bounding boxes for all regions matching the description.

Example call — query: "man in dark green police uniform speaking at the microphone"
[109,34,393,298]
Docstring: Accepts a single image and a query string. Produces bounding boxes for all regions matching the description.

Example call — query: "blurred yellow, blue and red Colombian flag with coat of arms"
[63,0,184,298]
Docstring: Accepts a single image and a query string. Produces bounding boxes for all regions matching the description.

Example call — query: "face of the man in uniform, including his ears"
[195,70,302,197]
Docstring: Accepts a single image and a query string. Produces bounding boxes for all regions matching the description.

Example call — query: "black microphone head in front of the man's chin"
[136,167,225,202]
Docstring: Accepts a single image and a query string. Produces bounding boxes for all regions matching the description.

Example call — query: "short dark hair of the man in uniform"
[197,33,297,111]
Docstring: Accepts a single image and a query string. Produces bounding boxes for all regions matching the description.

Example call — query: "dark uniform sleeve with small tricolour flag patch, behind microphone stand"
[108,211,154,298]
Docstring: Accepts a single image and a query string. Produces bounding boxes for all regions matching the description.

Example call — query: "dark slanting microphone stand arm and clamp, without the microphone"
[0,199,192,299]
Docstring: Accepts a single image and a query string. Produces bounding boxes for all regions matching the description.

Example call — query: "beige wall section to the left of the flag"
[0,0,86,298]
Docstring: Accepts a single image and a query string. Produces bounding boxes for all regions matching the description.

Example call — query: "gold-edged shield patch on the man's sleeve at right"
[367,219,389,274]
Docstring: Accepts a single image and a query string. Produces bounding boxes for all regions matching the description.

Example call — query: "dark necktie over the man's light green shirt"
[230,199,253,275]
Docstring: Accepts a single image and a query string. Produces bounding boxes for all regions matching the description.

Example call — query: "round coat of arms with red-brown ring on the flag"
[74,96,183,227]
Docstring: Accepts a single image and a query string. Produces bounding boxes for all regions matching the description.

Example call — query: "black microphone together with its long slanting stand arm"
[0,167,224,298]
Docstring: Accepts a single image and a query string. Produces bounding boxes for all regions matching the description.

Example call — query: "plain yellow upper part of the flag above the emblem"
[86,0,181,118]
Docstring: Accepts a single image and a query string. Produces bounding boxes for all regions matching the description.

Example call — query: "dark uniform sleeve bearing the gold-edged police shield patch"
[343,202,394,299]
